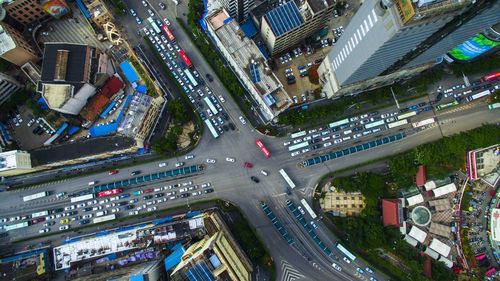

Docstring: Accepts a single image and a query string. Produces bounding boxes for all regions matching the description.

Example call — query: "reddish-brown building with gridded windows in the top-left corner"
[4,0,50,26]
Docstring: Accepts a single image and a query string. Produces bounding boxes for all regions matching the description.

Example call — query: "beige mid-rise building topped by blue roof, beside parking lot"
[260,0,335,55]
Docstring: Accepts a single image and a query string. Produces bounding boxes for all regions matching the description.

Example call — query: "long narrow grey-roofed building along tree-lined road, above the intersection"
[205,9,292,122]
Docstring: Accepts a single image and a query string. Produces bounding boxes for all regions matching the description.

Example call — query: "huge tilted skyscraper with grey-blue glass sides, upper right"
[318,0,500,97]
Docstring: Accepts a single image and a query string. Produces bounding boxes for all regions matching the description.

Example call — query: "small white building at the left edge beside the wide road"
[0,150,31,177]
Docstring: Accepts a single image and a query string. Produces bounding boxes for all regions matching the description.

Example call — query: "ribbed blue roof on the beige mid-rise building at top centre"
[264,1,304,36]
